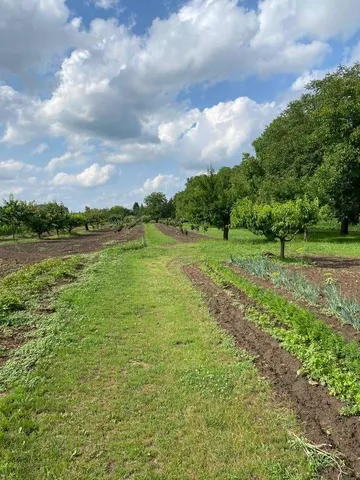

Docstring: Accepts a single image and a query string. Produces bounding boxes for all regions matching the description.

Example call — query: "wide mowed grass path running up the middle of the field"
[0,225,311,480]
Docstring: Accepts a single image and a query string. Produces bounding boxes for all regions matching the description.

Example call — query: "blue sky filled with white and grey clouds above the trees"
[0,0,360,211]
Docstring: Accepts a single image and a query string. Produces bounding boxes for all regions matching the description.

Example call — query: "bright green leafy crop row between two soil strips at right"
[207,262,360,414]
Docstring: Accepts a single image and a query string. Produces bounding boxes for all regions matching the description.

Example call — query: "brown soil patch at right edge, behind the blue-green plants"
[289,256,360,303]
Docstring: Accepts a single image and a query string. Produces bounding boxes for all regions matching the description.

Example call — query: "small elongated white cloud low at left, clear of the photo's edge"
[52,163,115,188]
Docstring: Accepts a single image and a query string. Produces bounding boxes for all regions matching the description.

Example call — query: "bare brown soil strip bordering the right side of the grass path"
[184,266,360,479]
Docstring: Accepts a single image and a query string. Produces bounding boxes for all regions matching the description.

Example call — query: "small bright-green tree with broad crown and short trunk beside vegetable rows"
[231,197,319,260]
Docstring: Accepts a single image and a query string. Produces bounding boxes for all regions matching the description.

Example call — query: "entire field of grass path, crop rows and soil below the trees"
[0,224,360,480]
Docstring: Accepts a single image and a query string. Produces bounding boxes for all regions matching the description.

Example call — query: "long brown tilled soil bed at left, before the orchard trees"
[0,225,144,278]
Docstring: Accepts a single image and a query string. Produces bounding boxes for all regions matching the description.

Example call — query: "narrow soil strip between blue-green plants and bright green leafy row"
[227,264,360,343]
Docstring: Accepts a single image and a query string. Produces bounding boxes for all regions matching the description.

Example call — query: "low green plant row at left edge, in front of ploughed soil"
[0,255,87,324]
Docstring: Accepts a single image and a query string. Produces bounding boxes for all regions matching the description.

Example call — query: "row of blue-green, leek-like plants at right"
[230,256,360,330]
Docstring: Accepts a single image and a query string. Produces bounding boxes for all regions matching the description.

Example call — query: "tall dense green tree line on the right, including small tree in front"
[174,64,360,256]
